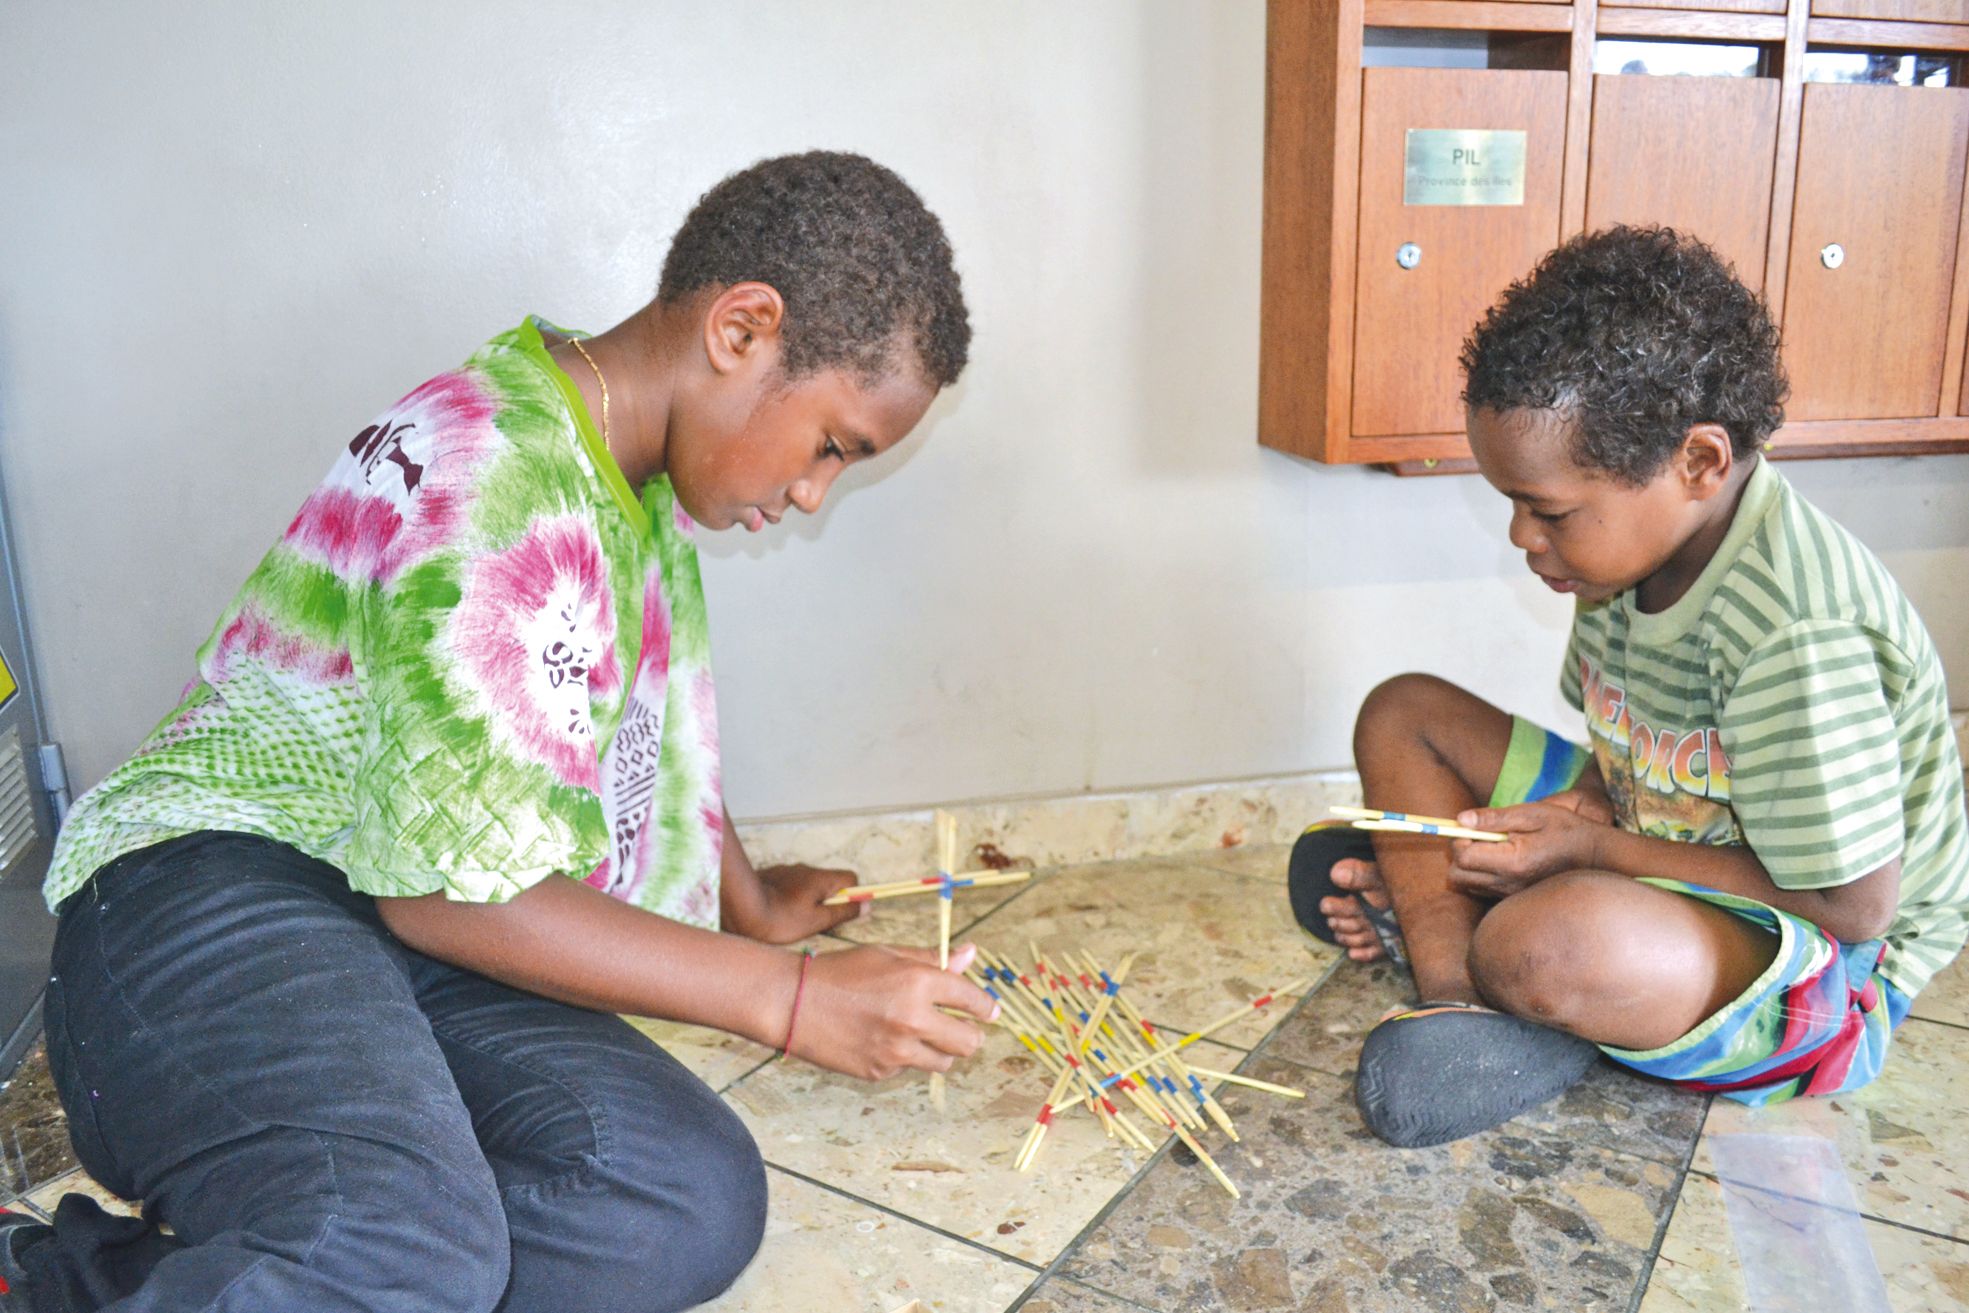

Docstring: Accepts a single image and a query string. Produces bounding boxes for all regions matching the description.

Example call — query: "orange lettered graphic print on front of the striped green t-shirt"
[1579,657,1743,844]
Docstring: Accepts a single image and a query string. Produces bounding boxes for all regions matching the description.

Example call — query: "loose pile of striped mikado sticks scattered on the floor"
[965,945,1307,1199]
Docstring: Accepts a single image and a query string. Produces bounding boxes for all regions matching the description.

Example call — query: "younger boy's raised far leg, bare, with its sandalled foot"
[1329,675,1512,1002]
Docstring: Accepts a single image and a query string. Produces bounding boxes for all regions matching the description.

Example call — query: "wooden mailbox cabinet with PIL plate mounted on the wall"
[1258,0,1969,472]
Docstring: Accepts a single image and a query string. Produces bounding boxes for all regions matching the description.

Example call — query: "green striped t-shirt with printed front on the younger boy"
[1561,461,1969,994]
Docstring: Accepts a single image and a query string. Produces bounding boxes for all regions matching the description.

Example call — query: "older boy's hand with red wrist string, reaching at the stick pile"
[794,940,998,1081]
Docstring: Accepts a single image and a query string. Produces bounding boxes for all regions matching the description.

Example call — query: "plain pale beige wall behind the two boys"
[0,0,1969,815]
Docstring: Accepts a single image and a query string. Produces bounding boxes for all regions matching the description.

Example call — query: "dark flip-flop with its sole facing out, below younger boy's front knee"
[1355,1002,1599,1150]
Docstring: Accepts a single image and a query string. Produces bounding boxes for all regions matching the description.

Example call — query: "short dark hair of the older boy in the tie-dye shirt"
[656,150,971,388]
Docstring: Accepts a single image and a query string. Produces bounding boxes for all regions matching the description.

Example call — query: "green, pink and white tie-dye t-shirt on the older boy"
[45,319,723,927]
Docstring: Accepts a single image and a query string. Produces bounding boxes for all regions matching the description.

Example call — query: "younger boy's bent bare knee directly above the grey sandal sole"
[1467,874,1624,1030]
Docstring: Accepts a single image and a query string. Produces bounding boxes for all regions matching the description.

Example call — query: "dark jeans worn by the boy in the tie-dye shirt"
[28,833,766,1313]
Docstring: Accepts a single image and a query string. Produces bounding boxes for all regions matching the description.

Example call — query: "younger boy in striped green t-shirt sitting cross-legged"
[1292,228,1969,1146]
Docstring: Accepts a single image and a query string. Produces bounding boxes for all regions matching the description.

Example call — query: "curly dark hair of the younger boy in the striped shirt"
[1461,226,1788,484]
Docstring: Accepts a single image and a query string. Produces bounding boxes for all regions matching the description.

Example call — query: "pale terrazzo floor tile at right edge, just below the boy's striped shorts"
[1691,1020,1969,1240]
